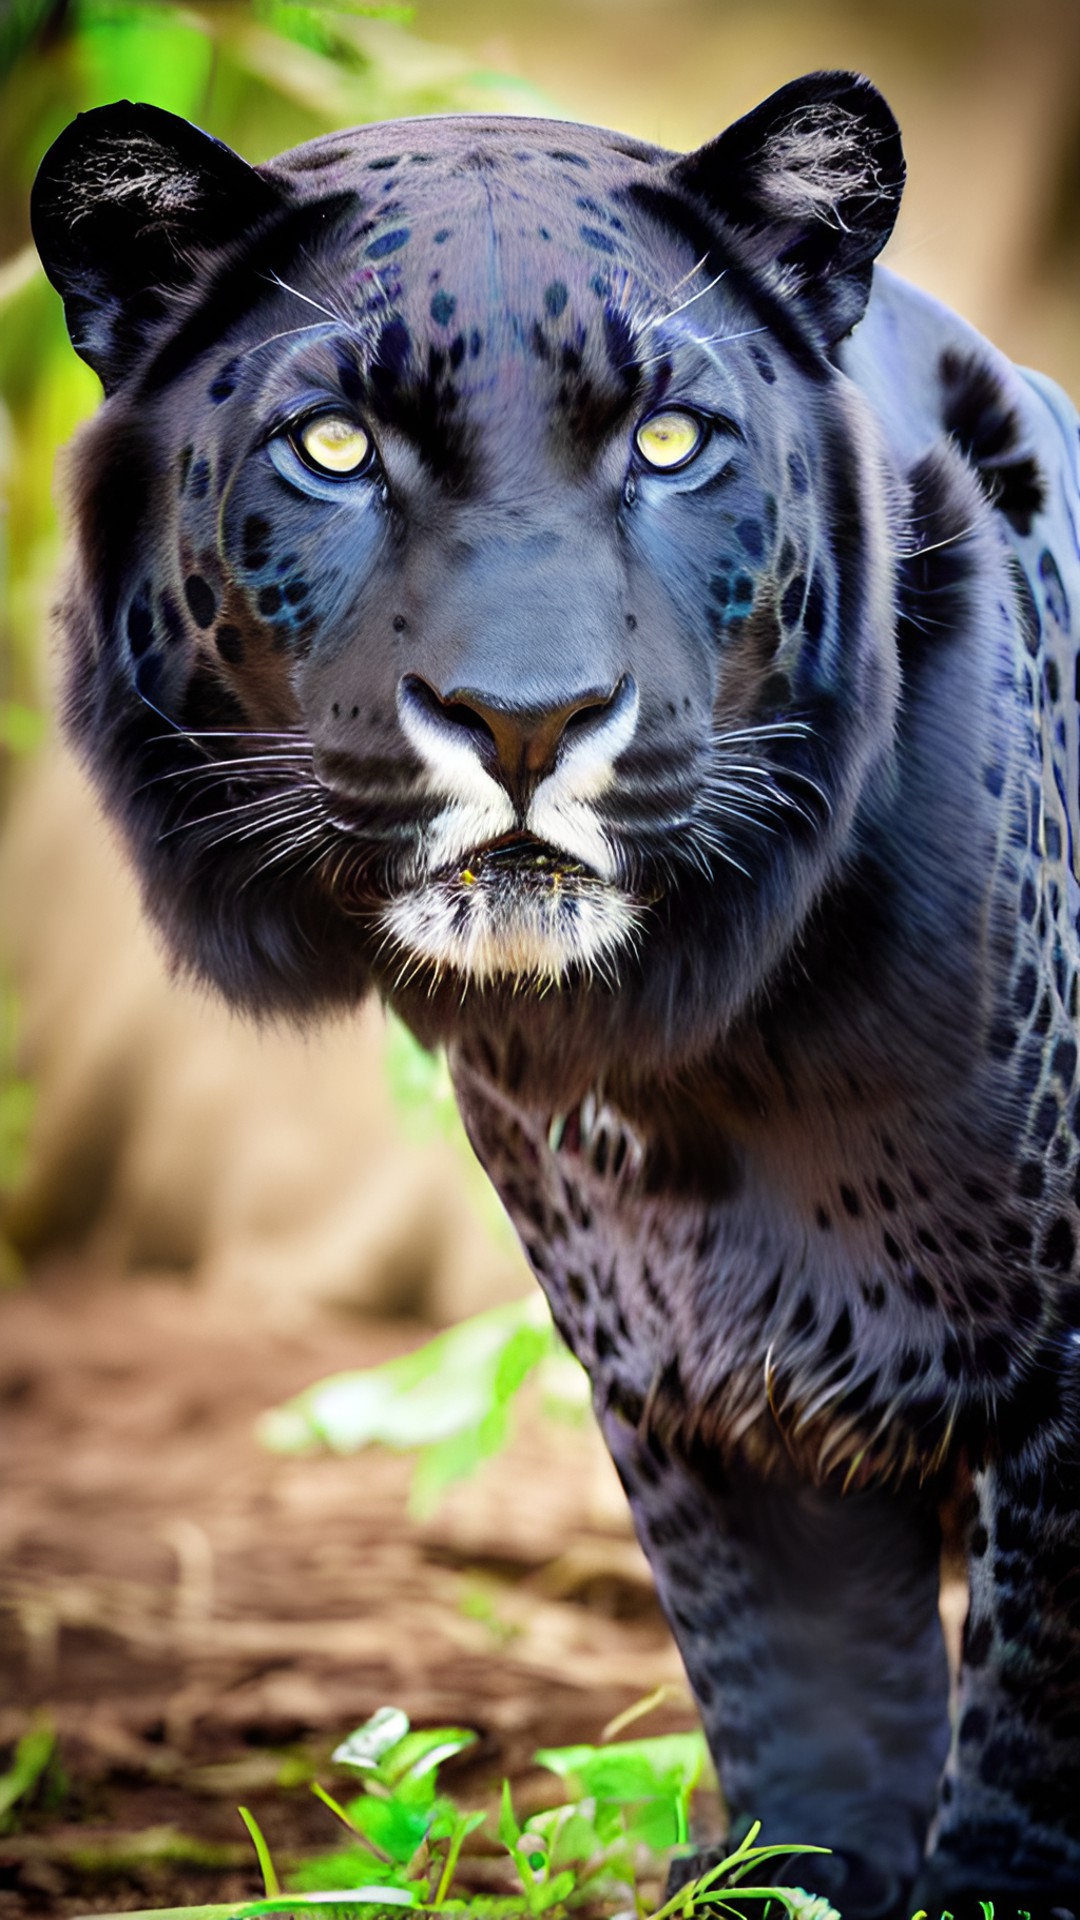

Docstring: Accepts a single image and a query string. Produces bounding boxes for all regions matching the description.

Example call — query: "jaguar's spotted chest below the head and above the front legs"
[459,1052,1049,1478]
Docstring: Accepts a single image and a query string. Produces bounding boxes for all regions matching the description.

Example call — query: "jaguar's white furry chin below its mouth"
[380,839,646,991]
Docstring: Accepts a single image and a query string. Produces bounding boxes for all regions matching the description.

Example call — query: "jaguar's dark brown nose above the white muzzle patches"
[402,674,621,810]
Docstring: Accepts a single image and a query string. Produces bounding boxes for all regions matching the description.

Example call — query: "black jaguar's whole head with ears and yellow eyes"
[35,75,903,1090]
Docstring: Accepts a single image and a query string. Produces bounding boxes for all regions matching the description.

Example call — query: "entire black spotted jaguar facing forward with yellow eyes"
[35,75,1080,1920]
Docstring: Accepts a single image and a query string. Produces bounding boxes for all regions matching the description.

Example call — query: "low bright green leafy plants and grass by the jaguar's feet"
[88,1707,836,1920]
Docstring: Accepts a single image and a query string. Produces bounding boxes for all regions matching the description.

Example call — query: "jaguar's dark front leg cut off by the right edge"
[919,1443,1080,1920]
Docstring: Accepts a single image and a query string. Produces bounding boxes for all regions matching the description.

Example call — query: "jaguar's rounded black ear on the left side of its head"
[31,100,282,394]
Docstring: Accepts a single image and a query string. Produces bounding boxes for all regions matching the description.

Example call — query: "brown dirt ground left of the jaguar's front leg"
[0,1267,692,1920]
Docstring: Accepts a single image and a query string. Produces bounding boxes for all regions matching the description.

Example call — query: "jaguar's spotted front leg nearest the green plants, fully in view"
[603,1413,947,1920]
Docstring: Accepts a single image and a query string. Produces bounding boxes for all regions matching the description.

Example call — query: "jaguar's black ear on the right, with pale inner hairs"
[675,73,905,348]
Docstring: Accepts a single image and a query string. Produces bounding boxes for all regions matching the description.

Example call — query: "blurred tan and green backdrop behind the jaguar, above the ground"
[0,0,1080,1323]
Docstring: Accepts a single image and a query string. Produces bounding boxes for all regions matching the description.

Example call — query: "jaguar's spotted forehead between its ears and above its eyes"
[247,121,726,484]
